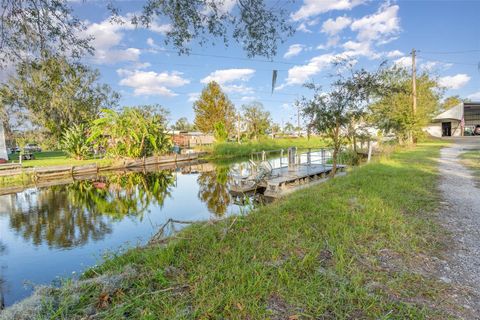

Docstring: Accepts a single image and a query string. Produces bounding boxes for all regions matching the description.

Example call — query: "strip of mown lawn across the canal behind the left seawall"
[10,151,111,168]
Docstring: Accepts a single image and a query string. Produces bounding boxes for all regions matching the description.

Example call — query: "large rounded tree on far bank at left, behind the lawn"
[0,57,118,141]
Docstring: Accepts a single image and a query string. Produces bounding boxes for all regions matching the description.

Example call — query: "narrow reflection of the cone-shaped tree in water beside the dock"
[197,166,231,217]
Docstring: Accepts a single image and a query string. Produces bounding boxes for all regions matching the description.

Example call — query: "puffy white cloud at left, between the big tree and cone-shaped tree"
[117,69,190,97]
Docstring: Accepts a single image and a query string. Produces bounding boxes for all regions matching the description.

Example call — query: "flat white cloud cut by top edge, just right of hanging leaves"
[291,0,365,21]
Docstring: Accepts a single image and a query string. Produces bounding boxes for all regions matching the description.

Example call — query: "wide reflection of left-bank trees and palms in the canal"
[6,171,174,248]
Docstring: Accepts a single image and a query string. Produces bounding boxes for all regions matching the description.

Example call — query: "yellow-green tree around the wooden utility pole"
[369,67,442,143]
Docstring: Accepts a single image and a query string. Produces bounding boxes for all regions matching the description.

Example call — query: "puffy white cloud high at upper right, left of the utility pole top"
[350,3,401,43]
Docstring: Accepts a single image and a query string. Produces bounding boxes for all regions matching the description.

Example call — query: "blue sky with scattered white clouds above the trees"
[67,0,480,124]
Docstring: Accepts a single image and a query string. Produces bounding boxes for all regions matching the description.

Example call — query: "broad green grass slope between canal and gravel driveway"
[38,143,458,319]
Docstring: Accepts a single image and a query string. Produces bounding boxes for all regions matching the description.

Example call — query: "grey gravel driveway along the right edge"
[439,137,480,319]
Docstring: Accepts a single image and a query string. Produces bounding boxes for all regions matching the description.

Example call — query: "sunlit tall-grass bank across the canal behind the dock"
[210,137,327,158]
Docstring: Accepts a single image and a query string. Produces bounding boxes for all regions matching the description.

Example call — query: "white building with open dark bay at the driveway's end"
[425,102,480,137]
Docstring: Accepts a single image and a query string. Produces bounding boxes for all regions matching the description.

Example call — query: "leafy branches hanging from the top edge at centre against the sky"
[119,0,294,58]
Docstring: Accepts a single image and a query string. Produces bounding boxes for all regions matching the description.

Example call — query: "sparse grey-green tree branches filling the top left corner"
[0,0,93,67]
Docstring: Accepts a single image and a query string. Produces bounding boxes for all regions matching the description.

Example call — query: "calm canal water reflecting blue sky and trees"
[0,163,252,306]
